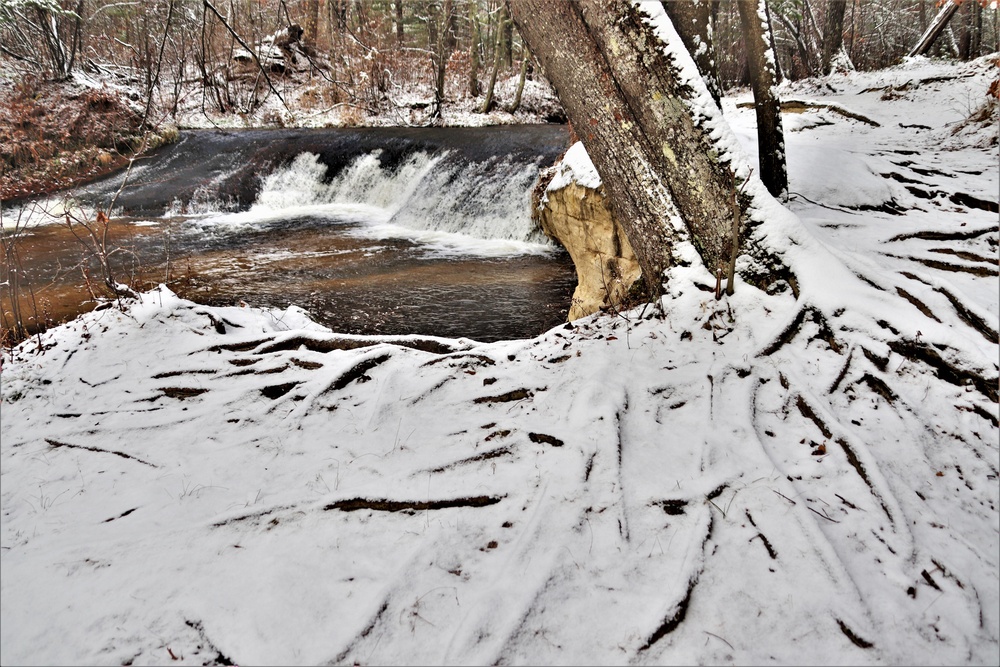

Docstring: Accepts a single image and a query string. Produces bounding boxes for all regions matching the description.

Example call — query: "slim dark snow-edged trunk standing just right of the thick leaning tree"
[736,0,788,197]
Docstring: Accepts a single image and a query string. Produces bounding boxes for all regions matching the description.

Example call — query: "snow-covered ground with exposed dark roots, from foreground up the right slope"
[0,60,1000,665]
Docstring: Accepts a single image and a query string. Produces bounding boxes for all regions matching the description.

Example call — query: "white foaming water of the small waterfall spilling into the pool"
[193,151,555,256]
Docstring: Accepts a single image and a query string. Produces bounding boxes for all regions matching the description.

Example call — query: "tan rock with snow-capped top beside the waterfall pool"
[534,143,641,322]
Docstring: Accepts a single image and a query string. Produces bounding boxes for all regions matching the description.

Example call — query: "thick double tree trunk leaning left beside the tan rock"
[510,0,735,293]
